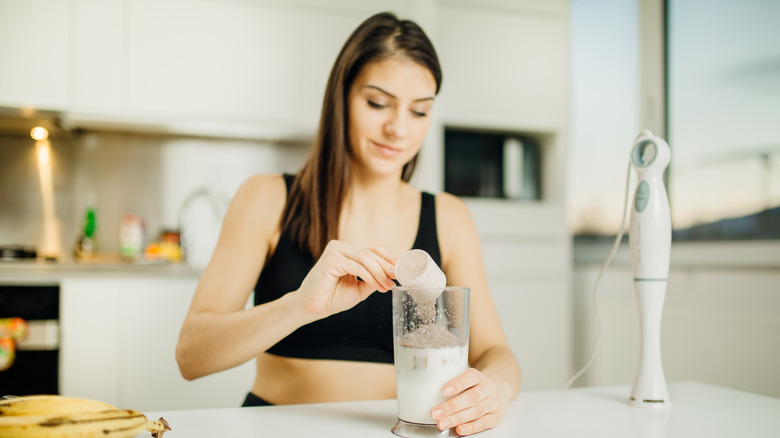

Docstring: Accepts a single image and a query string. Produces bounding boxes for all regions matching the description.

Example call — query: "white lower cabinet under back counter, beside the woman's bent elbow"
[60,277,254,411]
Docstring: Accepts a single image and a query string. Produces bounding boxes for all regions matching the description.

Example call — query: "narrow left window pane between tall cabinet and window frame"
[568,0,640,239]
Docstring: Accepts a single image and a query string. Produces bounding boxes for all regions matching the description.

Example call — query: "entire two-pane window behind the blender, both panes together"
[568,0,780,241]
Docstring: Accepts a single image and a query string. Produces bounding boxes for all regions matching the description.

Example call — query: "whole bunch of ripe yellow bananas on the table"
[0,395,171,438]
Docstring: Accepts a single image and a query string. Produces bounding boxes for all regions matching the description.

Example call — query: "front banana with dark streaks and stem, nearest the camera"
[0,409,147,438]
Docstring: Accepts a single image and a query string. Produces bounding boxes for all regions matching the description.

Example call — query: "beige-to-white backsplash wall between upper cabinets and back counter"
[0,132,308,256]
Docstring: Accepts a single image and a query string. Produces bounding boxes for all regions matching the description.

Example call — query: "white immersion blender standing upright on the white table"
[628,131,672,409]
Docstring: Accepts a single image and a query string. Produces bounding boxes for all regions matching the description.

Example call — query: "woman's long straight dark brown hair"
[282,12,442,257]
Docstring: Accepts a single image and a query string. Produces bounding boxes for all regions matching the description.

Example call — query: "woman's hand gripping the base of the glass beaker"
[431,368,510,435]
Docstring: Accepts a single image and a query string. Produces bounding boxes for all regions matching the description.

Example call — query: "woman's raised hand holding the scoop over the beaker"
[296,240,396,319]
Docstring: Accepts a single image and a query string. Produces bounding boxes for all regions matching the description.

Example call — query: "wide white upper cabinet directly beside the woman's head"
[119,0,400,134]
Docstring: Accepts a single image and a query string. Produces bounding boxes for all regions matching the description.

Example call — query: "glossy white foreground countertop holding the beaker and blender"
[142,382,780,438]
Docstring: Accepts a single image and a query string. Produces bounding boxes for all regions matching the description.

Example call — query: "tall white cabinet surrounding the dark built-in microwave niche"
[432,0,573,390]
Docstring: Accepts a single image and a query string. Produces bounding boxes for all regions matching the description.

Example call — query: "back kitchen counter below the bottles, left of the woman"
[0,260,203,284]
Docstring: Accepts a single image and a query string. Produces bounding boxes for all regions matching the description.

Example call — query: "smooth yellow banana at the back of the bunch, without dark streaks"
[0,395,116,417]
